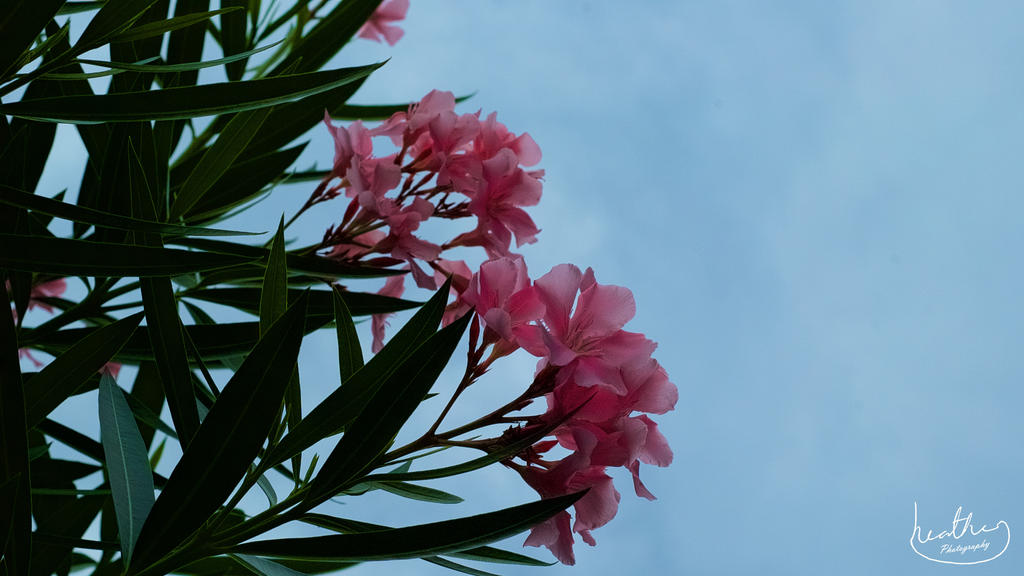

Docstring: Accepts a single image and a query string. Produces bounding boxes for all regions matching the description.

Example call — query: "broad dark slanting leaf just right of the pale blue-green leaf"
[131,291,306,568]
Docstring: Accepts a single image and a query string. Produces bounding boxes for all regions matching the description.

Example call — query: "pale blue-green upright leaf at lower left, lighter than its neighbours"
[99,373,154,561]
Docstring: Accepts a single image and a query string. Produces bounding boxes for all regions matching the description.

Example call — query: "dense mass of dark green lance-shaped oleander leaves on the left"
[0,0,580,576]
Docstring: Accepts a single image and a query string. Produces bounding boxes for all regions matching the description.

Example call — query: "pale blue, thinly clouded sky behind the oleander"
[28,0,1024,575]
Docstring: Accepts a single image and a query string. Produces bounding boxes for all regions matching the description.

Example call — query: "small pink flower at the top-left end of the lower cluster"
[462,255,544,356]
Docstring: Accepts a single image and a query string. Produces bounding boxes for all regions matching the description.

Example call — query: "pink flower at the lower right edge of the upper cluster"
[452,149,542,258]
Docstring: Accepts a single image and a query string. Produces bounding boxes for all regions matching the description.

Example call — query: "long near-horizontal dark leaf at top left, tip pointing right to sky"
[0,65,381,124]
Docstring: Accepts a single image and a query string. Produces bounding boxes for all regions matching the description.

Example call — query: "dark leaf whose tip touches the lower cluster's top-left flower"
[310,313,472,498]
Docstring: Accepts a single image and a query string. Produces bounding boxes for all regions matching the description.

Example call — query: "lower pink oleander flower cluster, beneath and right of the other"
[452,257,678,564]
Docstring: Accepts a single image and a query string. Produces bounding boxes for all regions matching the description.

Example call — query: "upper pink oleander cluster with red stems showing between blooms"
[315,90,544,351]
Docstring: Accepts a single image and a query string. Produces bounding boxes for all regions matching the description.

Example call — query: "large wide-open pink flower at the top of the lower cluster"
[517,264,656,395]
